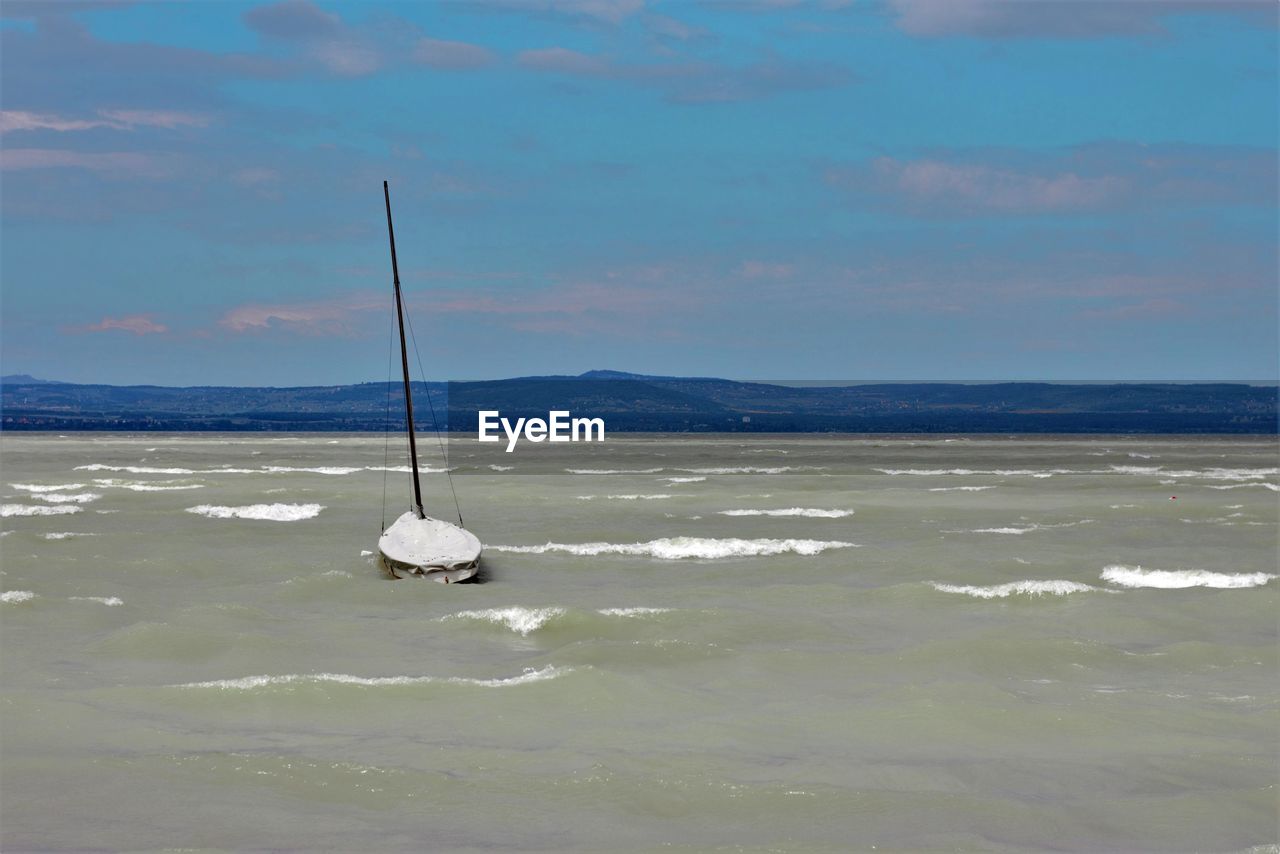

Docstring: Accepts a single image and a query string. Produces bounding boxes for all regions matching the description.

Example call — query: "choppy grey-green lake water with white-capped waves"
[0,434,1280,851]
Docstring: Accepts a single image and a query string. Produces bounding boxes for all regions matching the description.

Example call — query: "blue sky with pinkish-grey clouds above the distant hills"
[0,0,1280,385]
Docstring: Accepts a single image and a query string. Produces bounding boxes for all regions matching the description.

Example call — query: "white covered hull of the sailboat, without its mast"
[378,512,483,584]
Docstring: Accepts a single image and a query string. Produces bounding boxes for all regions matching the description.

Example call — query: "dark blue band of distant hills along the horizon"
[0,370,1280,434]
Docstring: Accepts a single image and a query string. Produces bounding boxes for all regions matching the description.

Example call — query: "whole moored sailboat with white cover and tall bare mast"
[378,181,483,584]
